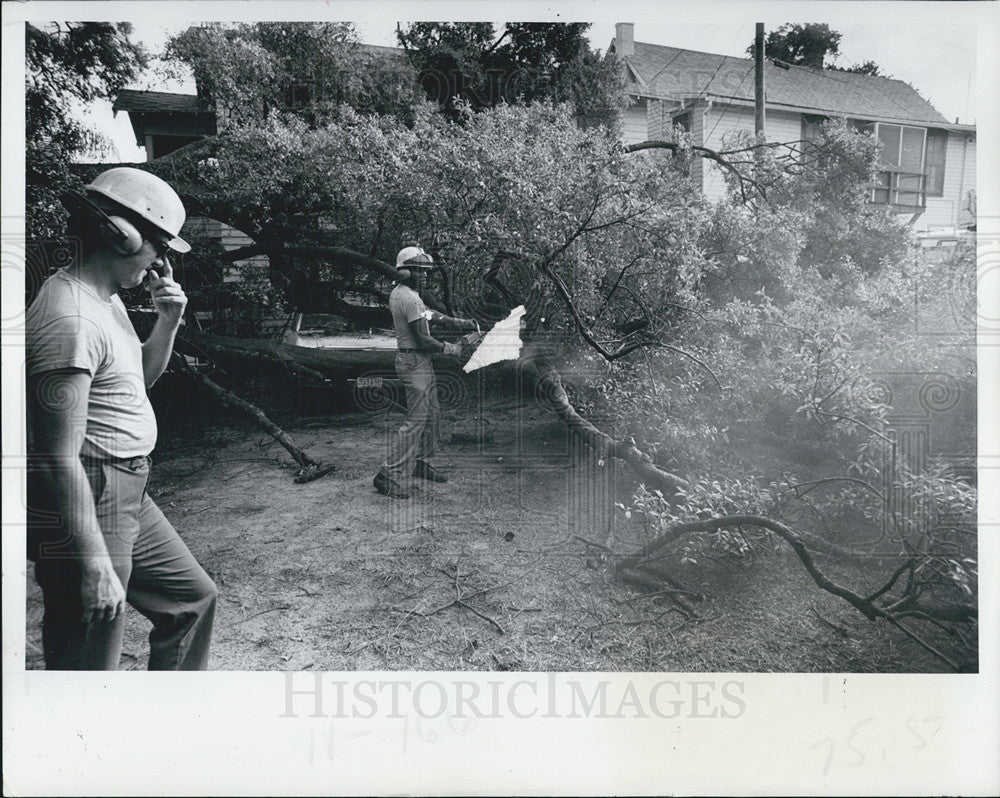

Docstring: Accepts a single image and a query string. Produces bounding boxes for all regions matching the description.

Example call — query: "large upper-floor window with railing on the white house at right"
[860,122,932,208]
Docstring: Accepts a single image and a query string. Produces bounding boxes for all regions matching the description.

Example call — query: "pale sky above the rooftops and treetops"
[74,9,977,161]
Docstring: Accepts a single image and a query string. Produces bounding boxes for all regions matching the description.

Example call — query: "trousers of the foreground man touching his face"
[28,457,217,670]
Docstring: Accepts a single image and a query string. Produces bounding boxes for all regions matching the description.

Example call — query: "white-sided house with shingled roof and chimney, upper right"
[609,22,976,232]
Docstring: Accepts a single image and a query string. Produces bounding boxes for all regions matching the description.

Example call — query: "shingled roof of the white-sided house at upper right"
[612,42,948,124]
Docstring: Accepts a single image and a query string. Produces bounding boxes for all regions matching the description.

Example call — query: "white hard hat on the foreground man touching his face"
[85,166,191,252]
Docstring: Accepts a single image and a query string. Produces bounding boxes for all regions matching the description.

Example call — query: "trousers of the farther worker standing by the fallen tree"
[382,352,441,482]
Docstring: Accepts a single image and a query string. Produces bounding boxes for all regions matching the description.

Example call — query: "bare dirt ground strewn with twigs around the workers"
[26,403,975,672]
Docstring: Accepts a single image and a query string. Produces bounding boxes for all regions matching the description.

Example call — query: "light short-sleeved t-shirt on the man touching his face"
[25,271,156,458]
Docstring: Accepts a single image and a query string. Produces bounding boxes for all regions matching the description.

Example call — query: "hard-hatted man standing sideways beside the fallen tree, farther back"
[375,246,478,499]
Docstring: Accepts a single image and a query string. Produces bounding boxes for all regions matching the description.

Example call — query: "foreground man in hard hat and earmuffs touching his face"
[26,167,216,670]
